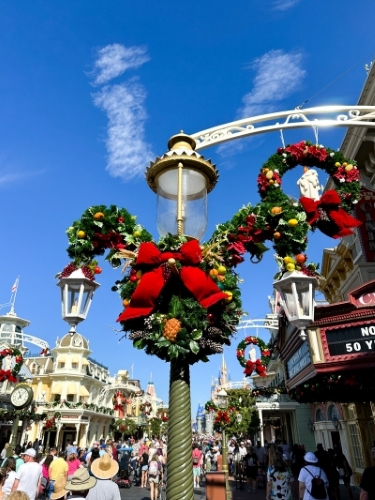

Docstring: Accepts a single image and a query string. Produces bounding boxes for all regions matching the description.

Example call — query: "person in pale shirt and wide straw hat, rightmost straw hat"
[86,453,121,500]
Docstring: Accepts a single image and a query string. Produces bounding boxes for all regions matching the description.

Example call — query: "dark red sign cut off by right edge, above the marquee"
[355,188,375,262]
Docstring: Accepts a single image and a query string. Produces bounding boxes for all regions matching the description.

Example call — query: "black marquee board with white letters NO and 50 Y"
[325,323,375,356]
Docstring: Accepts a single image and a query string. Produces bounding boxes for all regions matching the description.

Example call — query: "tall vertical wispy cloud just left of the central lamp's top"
[93,80,154,181]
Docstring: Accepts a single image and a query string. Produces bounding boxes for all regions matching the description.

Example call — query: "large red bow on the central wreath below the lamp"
[117,240,227,321]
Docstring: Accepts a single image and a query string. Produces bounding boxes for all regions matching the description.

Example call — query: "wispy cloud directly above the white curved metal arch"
[240,50,306,117]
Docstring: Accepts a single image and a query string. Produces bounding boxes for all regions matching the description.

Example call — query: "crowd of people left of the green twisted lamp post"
[0,438,167,500]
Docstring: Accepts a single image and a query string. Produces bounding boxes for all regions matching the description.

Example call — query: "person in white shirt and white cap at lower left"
[12,448,42,500]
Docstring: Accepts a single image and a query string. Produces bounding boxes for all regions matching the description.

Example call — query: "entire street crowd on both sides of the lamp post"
[0,438,375,500]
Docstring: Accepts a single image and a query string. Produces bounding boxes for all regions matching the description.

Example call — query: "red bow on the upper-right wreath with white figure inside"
[299,189,362,238]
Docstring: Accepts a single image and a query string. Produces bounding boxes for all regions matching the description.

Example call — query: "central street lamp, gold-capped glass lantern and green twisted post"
[146,132,218,498]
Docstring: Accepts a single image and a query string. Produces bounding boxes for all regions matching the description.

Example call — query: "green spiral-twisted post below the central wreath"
[167,360,194,500]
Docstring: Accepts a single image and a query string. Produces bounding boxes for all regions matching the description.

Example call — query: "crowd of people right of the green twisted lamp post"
[192,438,375,500]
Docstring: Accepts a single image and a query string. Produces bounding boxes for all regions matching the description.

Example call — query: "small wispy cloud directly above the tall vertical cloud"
[91,43,150,85]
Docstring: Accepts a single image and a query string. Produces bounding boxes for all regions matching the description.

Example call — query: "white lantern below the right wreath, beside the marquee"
[273,271,317,340]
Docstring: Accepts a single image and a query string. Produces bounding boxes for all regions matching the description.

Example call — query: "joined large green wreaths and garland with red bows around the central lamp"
[58,141,360,369]
